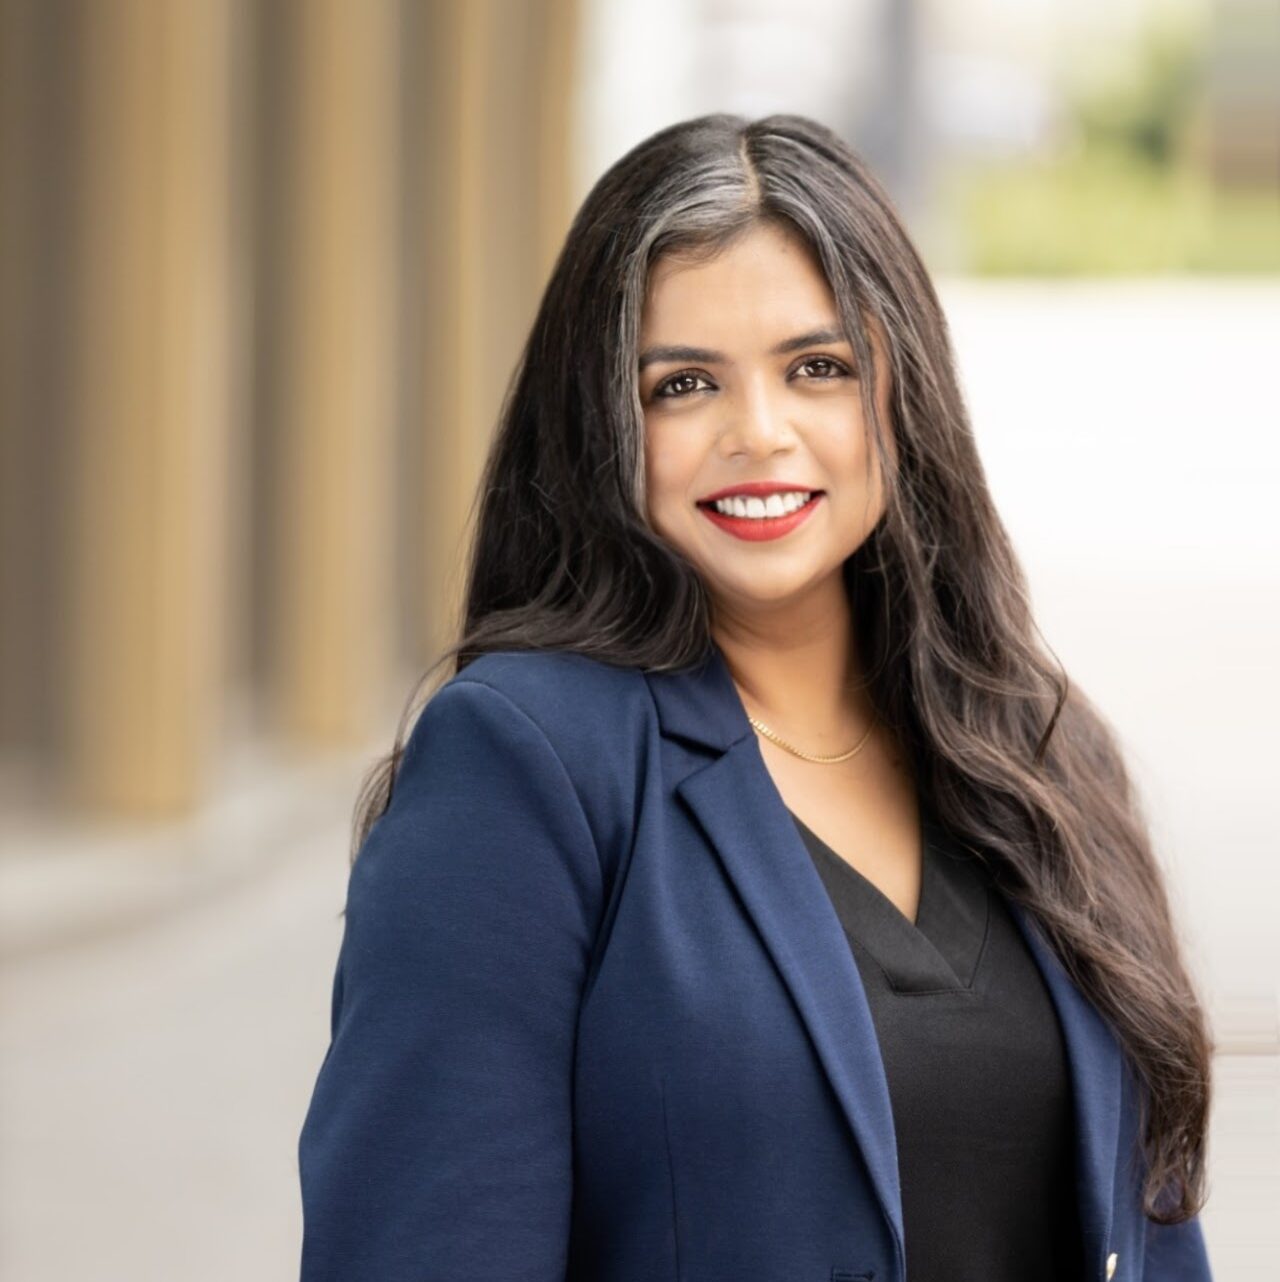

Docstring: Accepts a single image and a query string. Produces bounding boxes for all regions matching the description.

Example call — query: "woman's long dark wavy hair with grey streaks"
[351,114,1212,1224]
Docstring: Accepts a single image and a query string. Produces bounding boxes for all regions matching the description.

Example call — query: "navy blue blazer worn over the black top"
[298,650,1211,1282]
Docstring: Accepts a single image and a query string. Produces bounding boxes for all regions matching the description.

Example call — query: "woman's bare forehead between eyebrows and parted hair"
[641,224,836,341]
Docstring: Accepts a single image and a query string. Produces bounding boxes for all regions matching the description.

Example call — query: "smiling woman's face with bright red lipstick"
[639,226,895,614]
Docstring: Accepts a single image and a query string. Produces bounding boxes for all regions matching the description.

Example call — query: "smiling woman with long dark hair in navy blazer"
[299,115,1211,1282]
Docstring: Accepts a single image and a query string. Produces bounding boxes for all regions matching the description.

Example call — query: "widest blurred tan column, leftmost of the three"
[68,0,233,812]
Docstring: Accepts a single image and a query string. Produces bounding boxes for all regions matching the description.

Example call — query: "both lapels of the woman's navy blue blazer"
[645,646,1121,1272]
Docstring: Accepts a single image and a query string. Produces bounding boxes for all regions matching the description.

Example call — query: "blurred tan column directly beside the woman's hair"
[416,0,578,658]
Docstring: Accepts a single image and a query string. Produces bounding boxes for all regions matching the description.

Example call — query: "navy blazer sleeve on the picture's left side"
[298,677,603,1282]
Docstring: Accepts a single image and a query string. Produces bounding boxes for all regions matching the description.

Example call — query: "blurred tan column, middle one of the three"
[268,0,399,744]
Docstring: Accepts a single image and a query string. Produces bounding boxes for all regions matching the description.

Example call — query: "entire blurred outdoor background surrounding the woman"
[0,0,1280,1282]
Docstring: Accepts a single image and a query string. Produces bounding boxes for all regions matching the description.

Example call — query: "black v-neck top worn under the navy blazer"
[791,801,1084,1282]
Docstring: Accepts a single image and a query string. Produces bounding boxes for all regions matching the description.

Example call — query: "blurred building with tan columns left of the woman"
[0,0,576,814]
